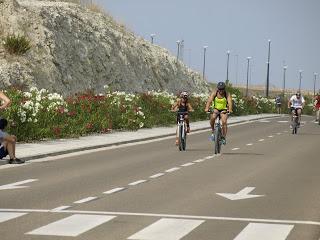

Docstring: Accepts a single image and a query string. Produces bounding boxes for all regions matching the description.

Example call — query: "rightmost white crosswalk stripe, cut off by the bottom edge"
[234,223,293,240]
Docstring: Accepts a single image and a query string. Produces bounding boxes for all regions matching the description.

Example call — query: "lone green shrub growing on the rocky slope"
[4,35,31,55]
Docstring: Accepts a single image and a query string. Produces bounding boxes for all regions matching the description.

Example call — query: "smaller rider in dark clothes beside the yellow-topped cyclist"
[171,91,193,145]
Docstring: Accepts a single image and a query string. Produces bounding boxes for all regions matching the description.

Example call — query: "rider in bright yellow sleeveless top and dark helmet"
[205,82,232,144]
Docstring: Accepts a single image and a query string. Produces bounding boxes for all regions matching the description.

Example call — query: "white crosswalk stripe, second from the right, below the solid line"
[128,218,204,240]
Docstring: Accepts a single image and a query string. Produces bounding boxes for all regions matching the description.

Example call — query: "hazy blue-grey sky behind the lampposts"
[96,0,320,91]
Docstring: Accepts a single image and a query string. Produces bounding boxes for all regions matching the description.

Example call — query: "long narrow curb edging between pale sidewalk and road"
[18,116,281,161]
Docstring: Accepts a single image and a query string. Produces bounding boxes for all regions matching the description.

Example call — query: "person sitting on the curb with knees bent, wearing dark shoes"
[0,118,25,164]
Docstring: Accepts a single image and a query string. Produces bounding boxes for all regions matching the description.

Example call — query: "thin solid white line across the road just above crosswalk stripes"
[0,208,320,226]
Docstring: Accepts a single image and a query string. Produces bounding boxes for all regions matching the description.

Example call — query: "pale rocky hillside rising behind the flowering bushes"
[0,0,208,95]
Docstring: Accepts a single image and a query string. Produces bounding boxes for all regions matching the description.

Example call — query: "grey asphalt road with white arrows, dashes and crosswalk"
[0,117,320,240]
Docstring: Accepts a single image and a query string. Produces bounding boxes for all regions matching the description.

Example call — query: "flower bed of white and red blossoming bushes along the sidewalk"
[1,86,284,141]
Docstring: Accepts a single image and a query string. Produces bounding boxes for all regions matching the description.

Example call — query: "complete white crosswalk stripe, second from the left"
[26,214,115,237]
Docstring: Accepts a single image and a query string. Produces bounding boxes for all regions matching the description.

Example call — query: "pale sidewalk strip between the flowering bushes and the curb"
[5,114,279,162]
